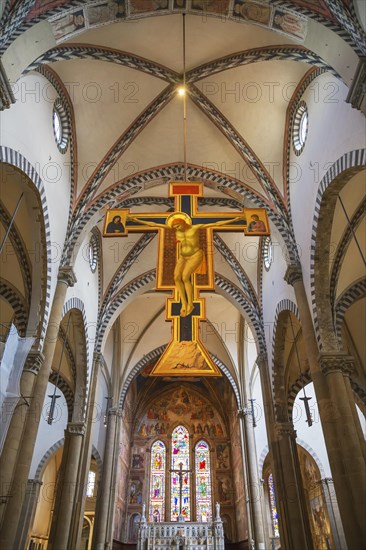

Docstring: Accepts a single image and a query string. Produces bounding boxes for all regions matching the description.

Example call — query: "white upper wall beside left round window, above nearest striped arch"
[0,73,70,310]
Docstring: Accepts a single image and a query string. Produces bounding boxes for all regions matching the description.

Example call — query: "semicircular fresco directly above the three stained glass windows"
[137,388,226,438]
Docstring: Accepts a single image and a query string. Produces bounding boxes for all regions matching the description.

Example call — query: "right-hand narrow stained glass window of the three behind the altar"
[195,441,212,522]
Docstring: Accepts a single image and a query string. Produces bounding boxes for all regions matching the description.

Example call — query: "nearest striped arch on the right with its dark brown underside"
[310,149,366,351]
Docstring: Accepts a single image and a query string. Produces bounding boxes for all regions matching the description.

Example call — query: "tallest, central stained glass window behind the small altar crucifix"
[171,426,191,521]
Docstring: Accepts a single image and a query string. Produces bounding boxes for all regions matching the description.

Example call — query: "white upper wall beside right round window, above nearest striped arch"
[290,73,365,303]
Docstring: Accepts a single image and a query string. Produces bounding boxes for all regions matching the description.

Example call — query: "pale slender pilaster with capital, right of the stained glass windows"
[238,409,265,550]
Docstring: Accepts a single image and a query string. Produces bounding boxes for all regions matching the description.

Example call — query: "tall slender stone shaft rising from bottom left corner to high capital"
[0,267,76,549]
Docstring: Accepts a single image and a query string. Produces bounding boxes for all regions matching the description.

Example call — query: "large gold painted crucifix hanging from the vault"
[103,182,269,376]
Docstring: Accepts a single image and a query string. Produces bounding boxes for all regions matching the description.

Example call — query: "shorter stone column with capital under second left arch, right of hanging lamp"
[47,422,85,550]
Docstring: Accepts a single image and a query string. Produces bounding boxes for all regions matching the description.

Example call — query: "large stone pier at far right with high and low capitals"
[285,265,366,550]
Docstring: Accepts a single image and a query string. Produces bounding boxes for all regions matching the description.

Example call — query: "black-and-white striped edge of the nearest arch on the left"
[0,147,52,351]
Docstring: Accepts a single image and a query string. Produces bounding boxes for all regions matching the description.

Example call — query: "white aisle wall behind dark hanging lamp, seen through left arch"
[28,382,67,479]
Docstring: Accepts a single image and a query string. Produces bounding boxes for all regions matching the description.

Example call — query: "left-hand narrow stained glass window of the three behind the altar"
[149,441,166,522]
